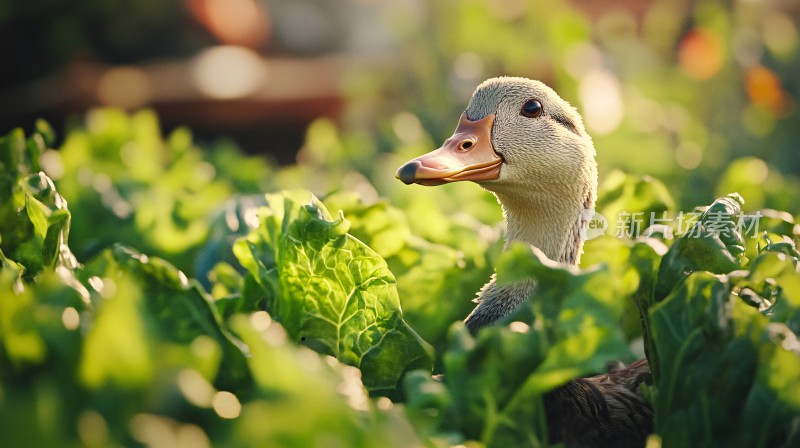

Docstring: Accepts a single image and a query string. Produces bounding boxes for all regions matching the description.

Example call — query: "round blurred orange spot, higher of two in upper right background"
[678,28,725,80]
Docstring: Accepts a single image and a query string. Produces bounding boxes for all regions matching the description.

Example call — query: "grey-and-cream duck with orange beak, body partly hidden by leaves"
[396,77,653,448]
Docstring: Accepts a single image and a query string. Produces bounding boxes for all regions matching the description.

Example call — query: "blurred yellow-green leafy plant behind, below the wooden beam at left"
[53,109,270,274]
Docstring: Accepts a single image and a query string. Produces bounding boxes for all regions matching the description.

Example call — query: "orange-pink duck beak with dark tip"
[395,112,503,185]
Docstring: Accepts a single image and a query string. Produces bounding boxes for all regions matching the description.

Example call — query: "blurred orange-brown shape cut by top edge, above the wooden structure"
[186,0,270,48]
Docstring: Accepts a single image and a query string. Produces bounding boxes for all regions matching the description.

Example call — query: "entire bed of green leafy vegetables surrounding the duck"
[0,111,800,447]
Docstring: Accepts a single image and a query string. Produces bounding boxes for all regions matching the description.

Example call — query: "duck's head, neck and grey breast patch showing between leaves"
[396,77,597,330]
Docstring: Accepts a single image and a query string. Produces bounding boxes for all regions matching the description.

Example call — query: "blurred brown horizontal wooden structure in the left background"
[0,53,346,163]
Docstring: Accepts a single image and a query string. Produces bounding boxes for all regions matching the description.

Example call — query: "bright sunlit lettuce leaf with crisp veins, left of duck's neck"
[234,192,431,390]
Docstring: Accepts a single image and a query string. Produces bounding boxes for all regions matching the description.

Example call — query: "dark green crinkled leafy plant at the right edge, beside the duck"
[643,195,800,446]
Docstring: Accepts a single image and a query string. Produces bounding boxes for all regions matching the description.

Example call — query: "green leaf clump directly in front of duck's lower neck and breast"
[406,244,632,447]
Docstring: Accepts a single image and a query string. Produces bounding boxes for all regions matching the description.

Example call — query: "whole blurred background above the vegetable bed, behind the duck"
[0,0,800,211]
